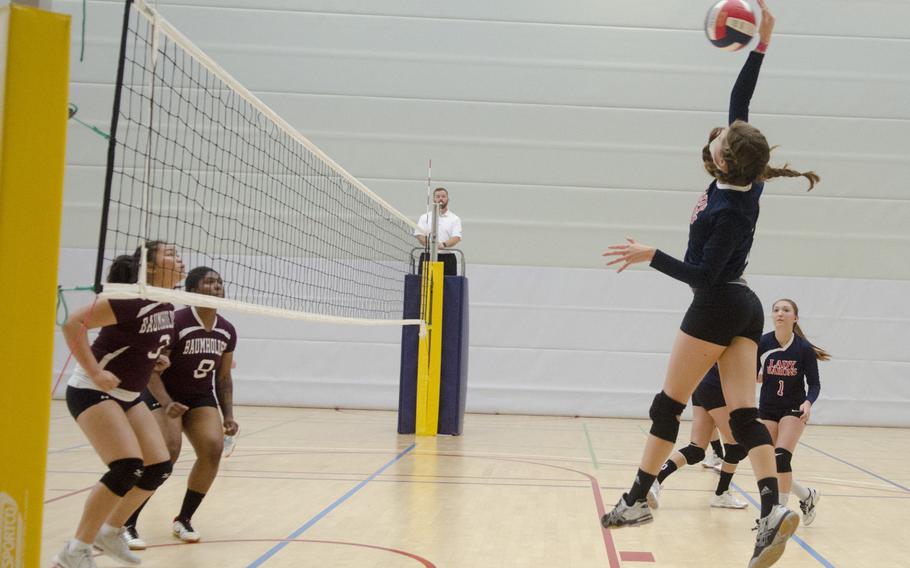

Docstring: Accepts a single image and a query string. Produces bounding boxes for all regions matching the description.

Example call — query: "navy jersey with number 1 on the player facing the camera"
[758,331,821,410]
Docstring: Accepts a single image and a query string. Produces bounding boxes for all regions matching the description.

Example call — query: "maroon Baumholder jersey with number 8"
[161,307,237,398]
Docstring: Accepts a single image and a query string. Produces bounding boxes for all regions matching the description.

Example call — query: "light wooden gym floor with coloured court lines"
[42,401,910,568]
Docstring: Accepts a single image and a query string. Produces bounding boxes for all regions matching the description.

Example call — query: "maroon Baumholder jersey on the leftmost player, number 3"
[92,300,174,392]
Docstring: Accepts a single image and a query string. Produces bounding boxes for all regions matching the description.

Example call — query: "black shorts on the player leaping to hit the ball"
[680,284,765,346]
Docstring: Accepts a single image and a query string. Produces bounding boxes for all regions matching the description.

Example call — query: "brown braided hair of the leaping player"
[701,120,821,191]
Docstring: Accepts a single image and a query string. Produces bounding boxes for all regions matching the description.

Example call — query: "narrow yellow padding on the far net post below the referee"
[415,262,443,436]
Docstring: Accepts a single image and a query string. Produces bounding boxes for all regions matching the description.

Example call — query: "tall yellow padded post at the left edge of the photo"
[0,5,70,568]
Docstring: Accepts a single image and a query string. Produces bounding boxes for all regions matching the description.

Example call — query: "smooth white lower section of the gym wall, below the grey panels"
[55,249,910,426]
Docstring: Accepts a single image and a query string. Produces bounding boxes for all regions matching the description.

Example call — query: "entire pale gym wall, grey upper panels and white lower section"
[54,0,910,425]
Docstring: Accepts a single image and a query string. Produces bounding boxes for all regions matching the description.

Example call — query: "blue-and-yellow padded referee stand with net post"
[398,206,468,436]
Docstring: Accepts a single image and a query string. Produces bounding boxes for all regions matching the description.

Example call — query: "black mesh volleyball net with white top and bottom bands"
[95,0,429,325]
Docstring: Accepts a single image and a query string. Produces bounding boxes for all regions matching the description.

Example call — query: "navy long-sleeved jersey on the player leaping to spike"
[651,51,764,288]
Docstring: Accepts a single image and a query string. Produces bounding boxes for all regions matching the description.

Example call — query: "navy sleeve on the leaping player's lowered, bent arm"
[651,211,749,288]
